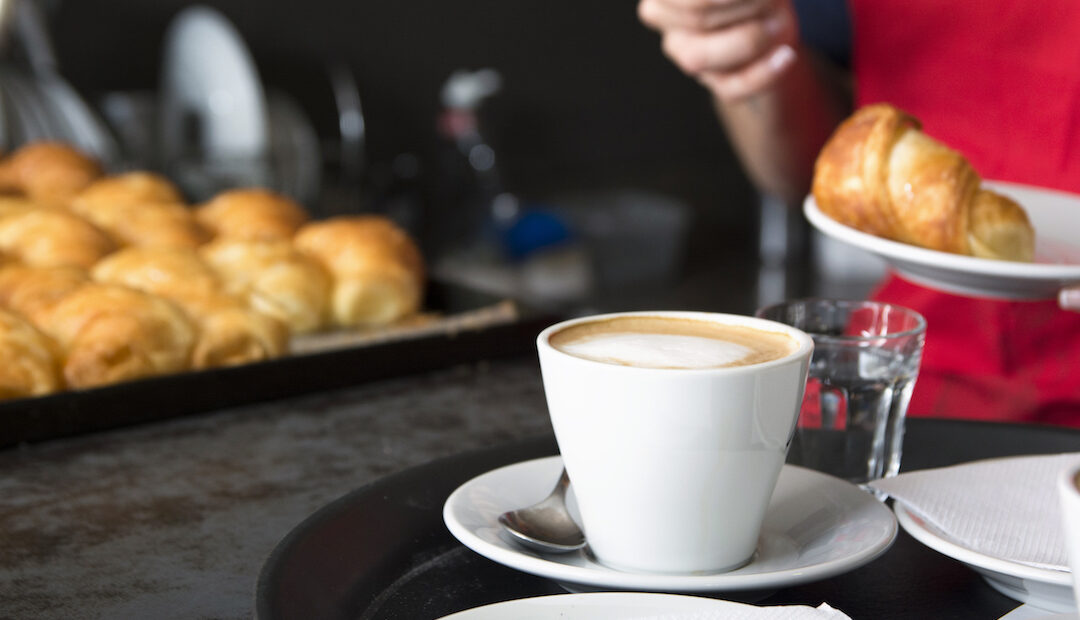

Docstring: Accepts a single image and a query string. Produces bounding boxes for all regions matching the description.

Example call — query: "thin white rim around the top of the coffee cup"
[537,310,814,376]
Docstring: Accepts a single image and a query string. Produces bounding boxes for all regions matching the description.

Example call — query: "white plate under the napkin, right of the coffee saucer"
[893,501,1076,612]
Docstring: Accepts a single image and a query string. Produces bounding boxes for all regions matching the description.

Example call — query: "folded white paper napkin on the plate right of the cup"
[869,453,1080,570]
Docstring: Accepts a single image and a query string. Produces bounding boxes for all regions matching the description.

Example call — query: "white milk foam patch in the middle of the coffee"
[561,334,754,368]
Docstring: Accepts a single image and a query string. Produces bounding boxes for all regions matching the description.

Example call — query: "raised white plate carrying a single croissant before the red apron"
[802,181,1080,299]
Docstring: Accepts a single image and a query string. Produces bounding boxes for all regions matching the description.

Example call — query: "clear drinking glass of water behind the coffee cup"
[757,299,927,485]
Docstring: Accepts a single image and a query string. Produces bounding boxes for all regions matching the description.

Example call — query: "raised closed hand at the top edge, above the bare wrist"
[637,0,798,102]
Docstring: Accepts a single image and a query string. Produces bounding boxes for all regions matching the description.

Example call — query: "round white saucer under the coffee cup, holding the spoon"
[443,457,896,592]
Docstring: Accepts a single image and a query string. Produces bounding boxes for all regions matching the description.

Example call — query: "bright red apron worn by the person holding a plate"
[850,0,1080,426]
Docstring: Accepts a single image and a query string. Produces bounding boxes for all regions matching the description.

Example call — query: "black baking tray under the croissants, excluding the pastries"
[0,282,555,447]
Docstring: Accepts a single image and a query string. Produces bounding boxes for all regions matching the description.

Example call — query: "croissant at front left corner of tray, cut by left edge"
[0,310,63,400]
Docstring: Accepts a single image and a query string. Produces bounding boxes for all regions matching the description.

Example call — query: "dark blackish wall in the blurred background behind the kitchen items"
[52,0,756,285]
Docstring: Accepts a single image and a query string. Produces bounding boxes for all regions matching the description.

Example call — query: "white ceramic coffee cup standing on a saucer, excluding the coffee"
[537,311,813,574]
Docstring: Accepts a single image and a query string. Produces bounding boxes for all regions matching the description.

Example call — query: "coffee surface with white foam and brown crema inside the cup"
[550,315,796,369]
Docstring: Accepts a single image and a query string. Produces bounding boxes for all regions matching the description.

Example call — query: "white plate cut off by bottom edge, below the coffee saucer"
[442,592,829,620]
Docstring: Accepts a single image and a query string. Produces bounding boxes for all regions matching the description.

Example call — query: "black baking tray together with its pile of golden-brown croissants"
[0,143,552,446]
